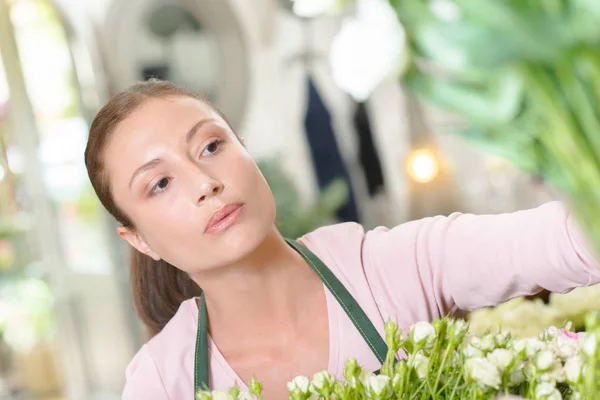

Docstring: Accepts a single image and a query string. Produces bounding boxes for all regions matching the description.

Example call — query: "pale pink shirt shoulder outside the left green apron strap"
[123,299,197,399]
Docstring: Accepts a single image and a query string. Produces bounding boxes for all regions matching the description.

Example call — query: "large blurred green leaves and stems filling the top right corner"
[390,0,600,255]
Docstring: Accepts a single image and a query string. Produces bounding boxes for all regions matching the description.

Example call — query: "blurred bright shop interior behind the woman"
[0,0,568,400]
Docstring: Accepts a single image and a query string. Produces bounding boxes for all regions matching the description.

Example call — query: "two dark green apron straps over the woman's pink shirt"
[194,239,388,398]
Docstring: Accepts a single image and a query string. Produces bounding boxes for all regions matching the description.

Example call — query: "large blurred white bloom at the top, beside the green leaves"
[328,0,408,101]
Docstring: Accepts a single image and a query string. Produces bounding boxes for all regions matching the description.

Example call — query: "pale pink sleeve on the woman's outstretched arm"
[363,202,600,323]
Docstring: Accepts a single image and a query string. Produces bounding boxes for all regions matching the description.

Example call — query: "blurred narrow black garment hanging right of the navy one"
[353,102,384,196]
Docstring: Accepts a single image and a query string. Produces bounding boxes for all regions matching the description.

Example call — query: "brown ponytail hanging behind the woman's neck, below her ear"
[129,249,202,337]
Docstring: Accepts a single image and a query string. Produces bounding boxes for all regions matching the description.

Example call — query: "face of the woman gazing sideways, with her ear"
[104,97,275,275]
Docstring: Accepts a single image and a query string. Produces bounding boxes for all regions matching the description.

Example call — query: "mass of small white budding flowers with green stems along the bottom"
[196,312,600,400]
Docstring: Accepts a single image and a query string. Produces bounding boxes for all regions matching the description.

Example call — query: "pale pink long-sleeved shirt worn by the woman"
[123,202,600,400]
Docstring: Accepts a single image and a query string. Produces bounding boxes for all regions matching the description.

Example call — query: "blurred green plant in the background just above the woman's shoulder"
[257,158,349,239]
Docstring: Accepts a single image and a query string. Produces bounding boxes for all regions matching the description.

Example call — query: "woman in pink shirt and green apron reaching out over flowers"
[85,81,600,400]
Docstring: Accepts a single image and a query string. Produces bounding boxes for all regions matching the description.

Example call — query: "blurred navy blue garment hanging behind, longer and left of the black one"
[304,76,359,222]
